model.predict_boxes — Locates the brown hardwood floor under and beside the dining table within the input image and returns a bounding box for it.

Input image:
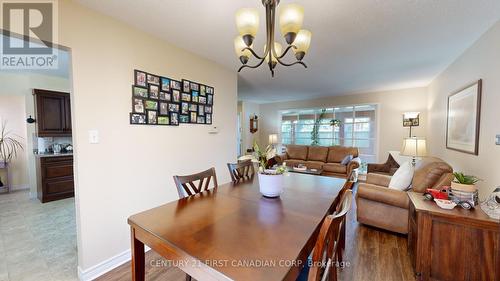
[97,185,415,281]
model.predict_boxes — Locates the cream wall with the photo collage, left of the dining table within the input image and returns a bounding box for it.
[59,0,237,274]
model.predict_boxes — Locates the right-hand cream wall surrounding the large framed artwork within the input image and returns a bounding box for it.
[427,22,500,198]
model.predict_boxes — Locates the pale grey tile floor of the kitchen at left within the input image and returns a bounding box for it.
[0,191,78,281]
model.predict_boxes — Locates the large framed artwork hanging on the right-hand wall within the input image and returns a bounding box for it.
[446,80,482,155]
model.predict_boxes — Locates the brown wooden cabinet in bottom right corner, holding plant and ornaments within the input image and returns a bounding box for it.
[408,192,500,281]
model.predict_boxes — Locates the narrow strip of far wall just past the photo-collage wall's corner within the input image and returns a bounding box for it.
[241,101,260,154]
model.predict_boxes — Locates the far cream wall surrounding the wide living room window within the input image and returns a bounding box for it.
[260,88,427,161]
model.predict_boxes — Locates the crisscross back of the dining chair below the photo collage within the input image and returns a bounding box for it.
[174,168,217,199]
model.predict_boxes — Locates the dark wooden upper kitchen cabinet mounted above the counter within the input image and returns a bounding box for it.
[34,89,72,137]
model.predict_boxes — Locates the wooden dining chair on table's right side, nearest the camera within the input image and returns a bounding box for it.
[297,190,352,281]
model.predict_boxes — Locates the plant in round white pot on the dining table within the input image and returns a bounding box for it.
[253,142,287,198]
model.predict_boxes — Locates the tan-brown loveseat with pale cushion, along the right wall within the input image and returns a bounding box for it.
[356,157,453,234]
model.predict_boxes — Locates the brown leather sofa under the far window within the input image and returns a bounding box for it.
[279,145,361,177]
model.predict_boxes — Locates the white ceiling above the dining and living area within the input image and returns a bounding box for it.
[78,0,500,103]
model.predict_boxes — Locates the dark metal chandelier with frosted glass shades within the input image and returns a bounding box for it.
[234,0,311,77]
